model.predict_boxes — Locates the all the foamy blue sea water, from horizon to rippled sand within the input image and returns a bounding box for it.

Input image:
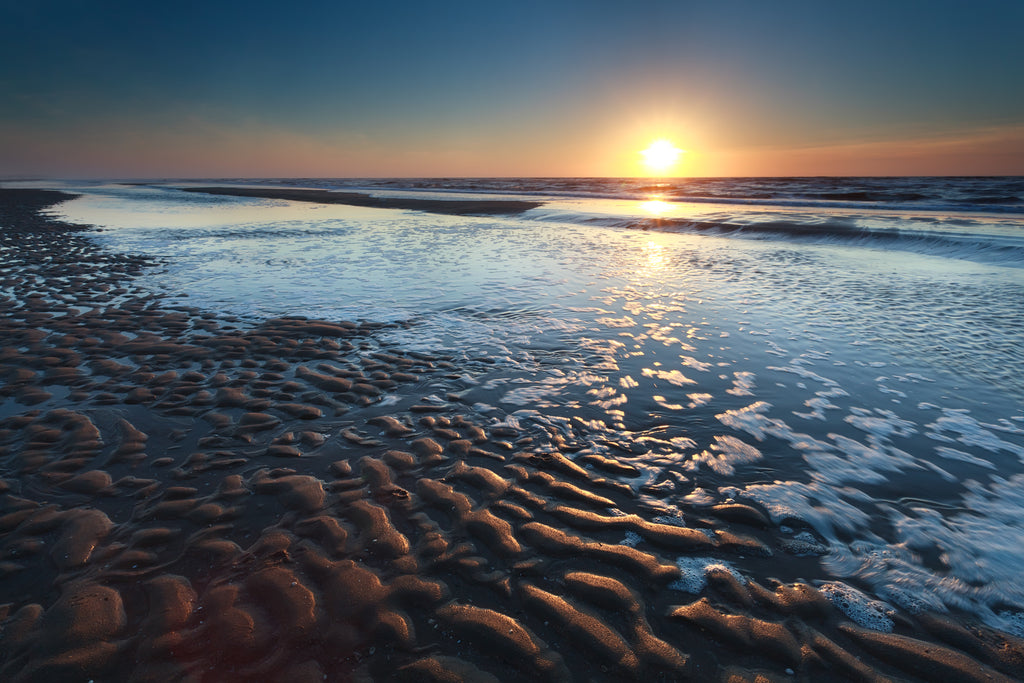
[46,178,1024,635]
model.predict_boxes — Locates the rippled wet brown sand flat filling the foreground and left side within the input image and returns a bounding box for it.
[0,188,1024,682]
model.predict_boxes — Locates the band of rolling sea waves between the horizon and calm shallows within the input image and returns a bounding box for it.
[151,177,1024,267]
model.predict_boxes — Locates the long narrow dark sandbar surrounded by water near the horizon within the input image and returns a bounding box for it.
[182,187,542,216]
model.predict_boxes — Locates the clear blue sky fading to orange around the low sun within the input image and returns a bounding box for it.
[0,0,1024,178]
